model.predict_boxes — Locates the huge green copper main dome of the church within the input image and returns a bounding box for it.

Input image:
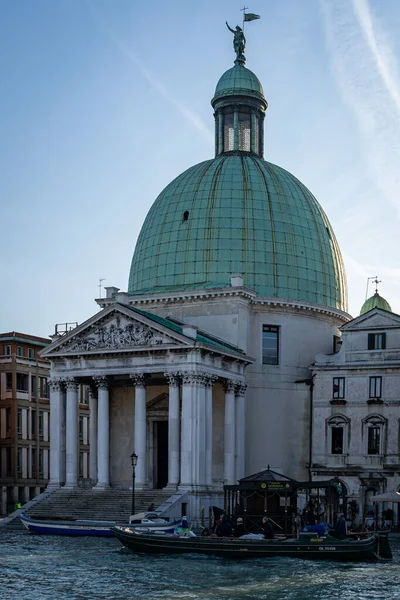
[128,152,347,310]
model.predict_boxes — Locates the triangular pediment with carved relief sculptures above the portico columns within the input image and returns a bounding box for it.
[42,304,192,357]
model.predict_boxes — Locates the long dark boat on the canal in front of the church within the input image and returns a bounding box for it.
[112,526,392,561]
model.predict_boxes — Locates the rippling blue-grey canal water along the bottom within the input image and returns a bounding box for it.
[0,532,400,600]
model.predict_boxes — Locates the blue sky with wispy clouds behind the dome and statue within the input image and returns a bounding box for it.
[0,0,400,336]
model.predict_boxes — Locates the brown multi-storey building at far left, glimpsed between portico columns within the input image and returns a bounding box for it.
[0,331,89,514]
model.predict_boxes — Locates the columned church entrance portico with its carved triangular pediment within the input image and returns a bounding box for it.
[42,302,252,491]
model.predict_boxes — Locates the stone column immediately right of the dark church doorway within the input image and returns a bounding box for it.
[165,373,180,488]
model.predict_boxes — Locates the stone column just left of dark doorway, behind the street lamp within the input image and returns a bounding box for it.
[131,373,147,489]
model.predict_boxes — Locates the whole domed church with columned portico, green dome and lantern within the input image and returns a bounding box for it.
[43,30,350,510]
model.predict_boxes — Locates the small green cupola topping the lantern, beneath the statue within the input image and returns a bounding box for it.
[212,63,265,103]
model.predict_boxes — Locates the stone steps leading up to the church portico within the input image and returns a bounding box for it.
[22,488,171,523]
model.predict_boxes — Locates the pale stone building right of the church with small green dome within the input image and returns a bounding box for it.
[312,293,400,522]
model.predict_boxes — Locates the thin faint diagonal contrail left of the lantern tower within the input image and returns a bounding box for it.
[86,0,214,142]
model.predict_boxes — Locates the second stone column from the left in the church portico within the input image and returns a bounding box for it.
[65,378,78,489]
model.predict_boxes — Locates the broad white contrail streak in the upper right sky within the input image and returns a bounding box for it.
[320,0,400,216]
